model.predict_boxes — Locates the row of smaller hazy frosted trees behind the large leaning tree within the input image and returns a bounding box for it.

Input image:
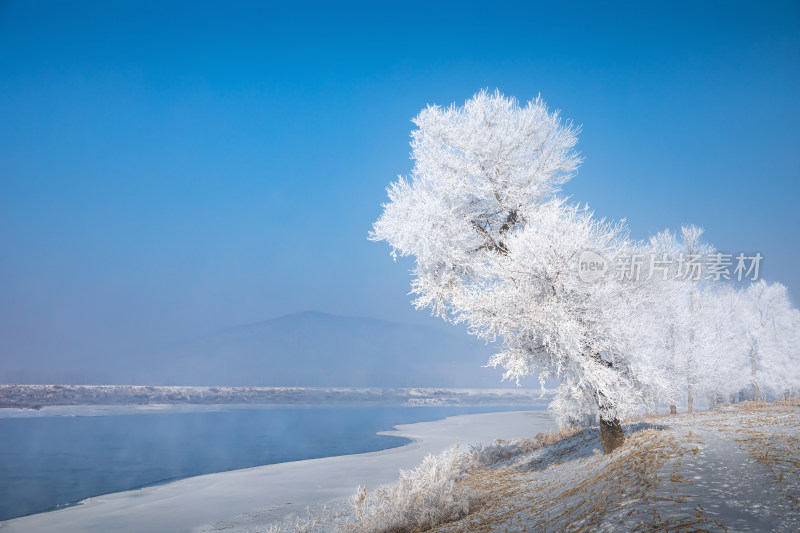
[636,226,800,413]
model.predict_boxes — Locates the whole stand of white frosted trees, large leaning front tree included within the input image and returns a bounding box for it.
[371,92,800,451]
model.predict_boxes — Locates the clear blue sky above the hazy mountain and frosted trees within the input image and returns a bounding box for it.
[0,0,800,362]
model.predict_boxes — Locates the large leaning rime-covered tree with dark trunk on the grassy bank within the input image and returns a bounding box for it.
[371,92,657,451]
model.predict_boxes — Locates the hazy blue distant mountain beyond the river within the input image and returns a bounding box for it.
[84,311,509,388]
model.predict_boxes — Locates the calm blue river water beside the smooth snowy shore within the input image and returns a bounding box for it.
[0,406,544,520]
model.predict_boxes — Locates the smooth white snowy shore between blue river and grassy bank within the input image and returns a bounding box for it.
[0,411,555,533]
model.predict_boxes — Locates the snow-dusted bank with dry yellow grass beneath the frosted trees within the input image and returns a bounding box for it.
[422,402,800,532]
